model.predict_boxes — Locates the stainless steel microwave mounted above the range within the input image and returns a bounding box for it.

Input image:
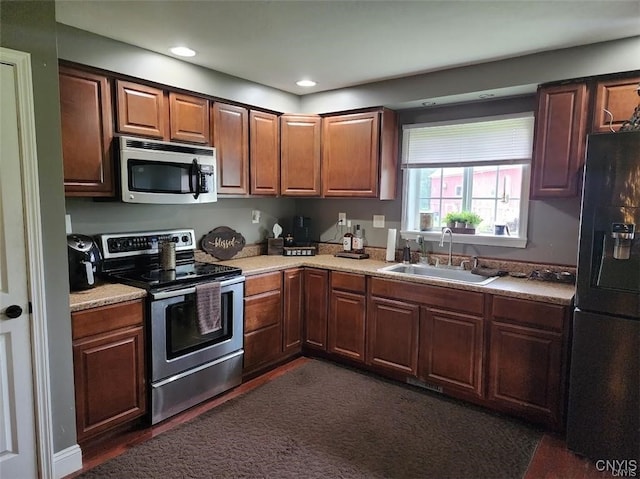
[119,136,218,204]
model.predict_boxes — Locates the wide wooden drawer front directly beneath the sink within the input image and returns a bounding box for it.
[370,278,484,316]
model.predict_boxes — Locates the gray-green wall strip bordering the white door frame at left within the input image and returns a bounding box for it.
[0,1,76,452]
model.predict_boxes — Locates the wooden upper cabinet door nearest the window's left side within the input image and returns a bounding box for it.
[322,111,380,198]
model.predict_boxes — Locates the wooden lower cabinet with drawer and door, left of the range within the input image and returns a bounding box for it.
[71,301,147,444]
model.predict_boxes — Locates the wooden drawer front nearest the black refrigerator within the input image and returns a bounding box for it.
[492,296,566,332]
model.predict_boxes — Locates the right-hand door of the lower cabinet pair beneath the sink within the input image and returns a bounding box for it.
[418,308,483,396]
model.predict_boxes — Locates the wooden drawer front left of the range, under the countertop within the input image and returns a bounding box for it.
[71,301,144,340]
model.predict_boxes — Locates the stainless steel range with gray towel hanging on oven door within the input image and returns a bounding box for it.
[97,229,245,424]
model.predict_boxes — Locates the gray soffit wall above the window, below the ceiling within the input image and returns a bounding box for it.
[301,36,640,113]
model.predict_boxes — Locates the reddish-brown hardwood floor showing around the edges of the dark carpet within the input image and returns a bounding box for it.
[64,357,613,479]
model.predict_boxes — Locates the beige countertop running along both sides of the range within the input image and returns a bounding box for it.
[70,251,575,312]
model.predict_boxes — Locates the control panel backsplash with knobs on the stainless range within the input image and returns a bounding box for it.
[98,229,195,259]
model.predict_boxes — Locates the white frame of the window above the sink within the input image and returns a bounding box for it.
[400,111,533,248]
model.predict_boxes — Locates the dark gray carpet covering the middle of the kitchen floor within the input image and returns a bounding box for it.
[80,360,542,479]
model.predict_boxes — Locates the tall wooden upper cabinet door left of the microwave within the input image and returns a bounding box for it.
[59,66,115,196]
